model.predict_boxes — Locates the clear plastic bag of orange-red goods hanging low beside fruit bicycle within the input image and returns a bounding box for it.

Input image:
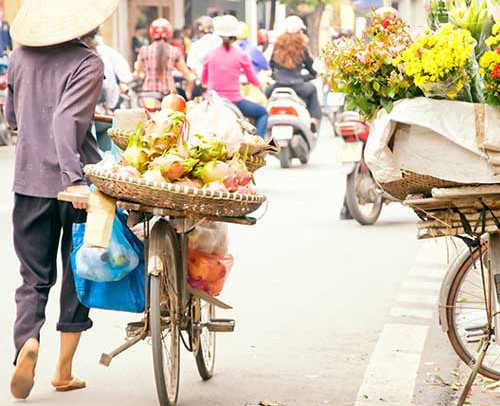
[188,249,234,296]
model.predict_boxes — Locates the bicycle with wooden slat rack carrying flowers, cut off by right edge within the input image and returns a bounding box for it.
[405,185,500,406]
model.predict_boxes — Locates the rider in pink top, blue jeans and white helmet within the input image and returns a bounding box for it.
[201,15,268,137]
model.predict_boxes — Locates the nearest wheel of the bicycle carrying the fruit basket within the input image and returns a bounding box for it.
[148,220,180,406]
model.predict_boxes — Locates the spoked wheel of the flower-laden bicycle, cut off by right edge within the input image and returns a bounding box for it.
[446,243,500,381]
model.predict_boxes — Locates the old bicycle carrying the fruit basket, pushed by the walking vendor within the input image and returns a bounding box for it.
[58,193,256,406]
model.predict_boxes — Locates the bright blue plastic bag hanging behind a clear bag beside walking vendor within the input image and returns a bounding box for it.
[71,210,146,313]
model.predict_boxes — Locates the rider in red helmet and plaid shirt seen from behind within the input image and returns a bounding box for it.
[135,18,193,95]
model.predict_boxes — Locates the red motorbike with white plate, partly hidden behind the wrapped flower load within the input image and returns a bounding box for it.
[335,111,386,225]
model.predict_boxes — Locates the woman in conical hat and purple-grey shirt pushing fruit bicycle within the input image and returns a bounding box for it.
[6,0,119,399]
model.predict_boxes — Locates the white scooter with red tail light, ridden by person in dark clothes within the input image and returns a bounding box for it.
[267,87,319,168]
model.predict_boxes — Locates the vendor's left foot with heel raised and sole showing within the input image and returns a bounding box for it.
[10,338,40,399]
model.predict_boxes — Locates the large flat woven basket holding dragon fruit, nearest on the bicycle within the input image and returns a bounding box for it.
[84,165,266,217]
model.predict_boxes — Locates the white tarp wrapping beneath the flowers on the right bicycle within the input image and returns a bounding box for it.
[365,97,500,183]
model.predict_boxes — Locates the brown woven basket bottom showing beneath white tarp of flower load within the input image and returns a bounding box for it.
[380,170,462,200]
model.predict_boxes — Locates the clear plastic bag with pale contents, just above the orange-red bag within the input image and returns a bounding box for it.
[189,221,228,256]
